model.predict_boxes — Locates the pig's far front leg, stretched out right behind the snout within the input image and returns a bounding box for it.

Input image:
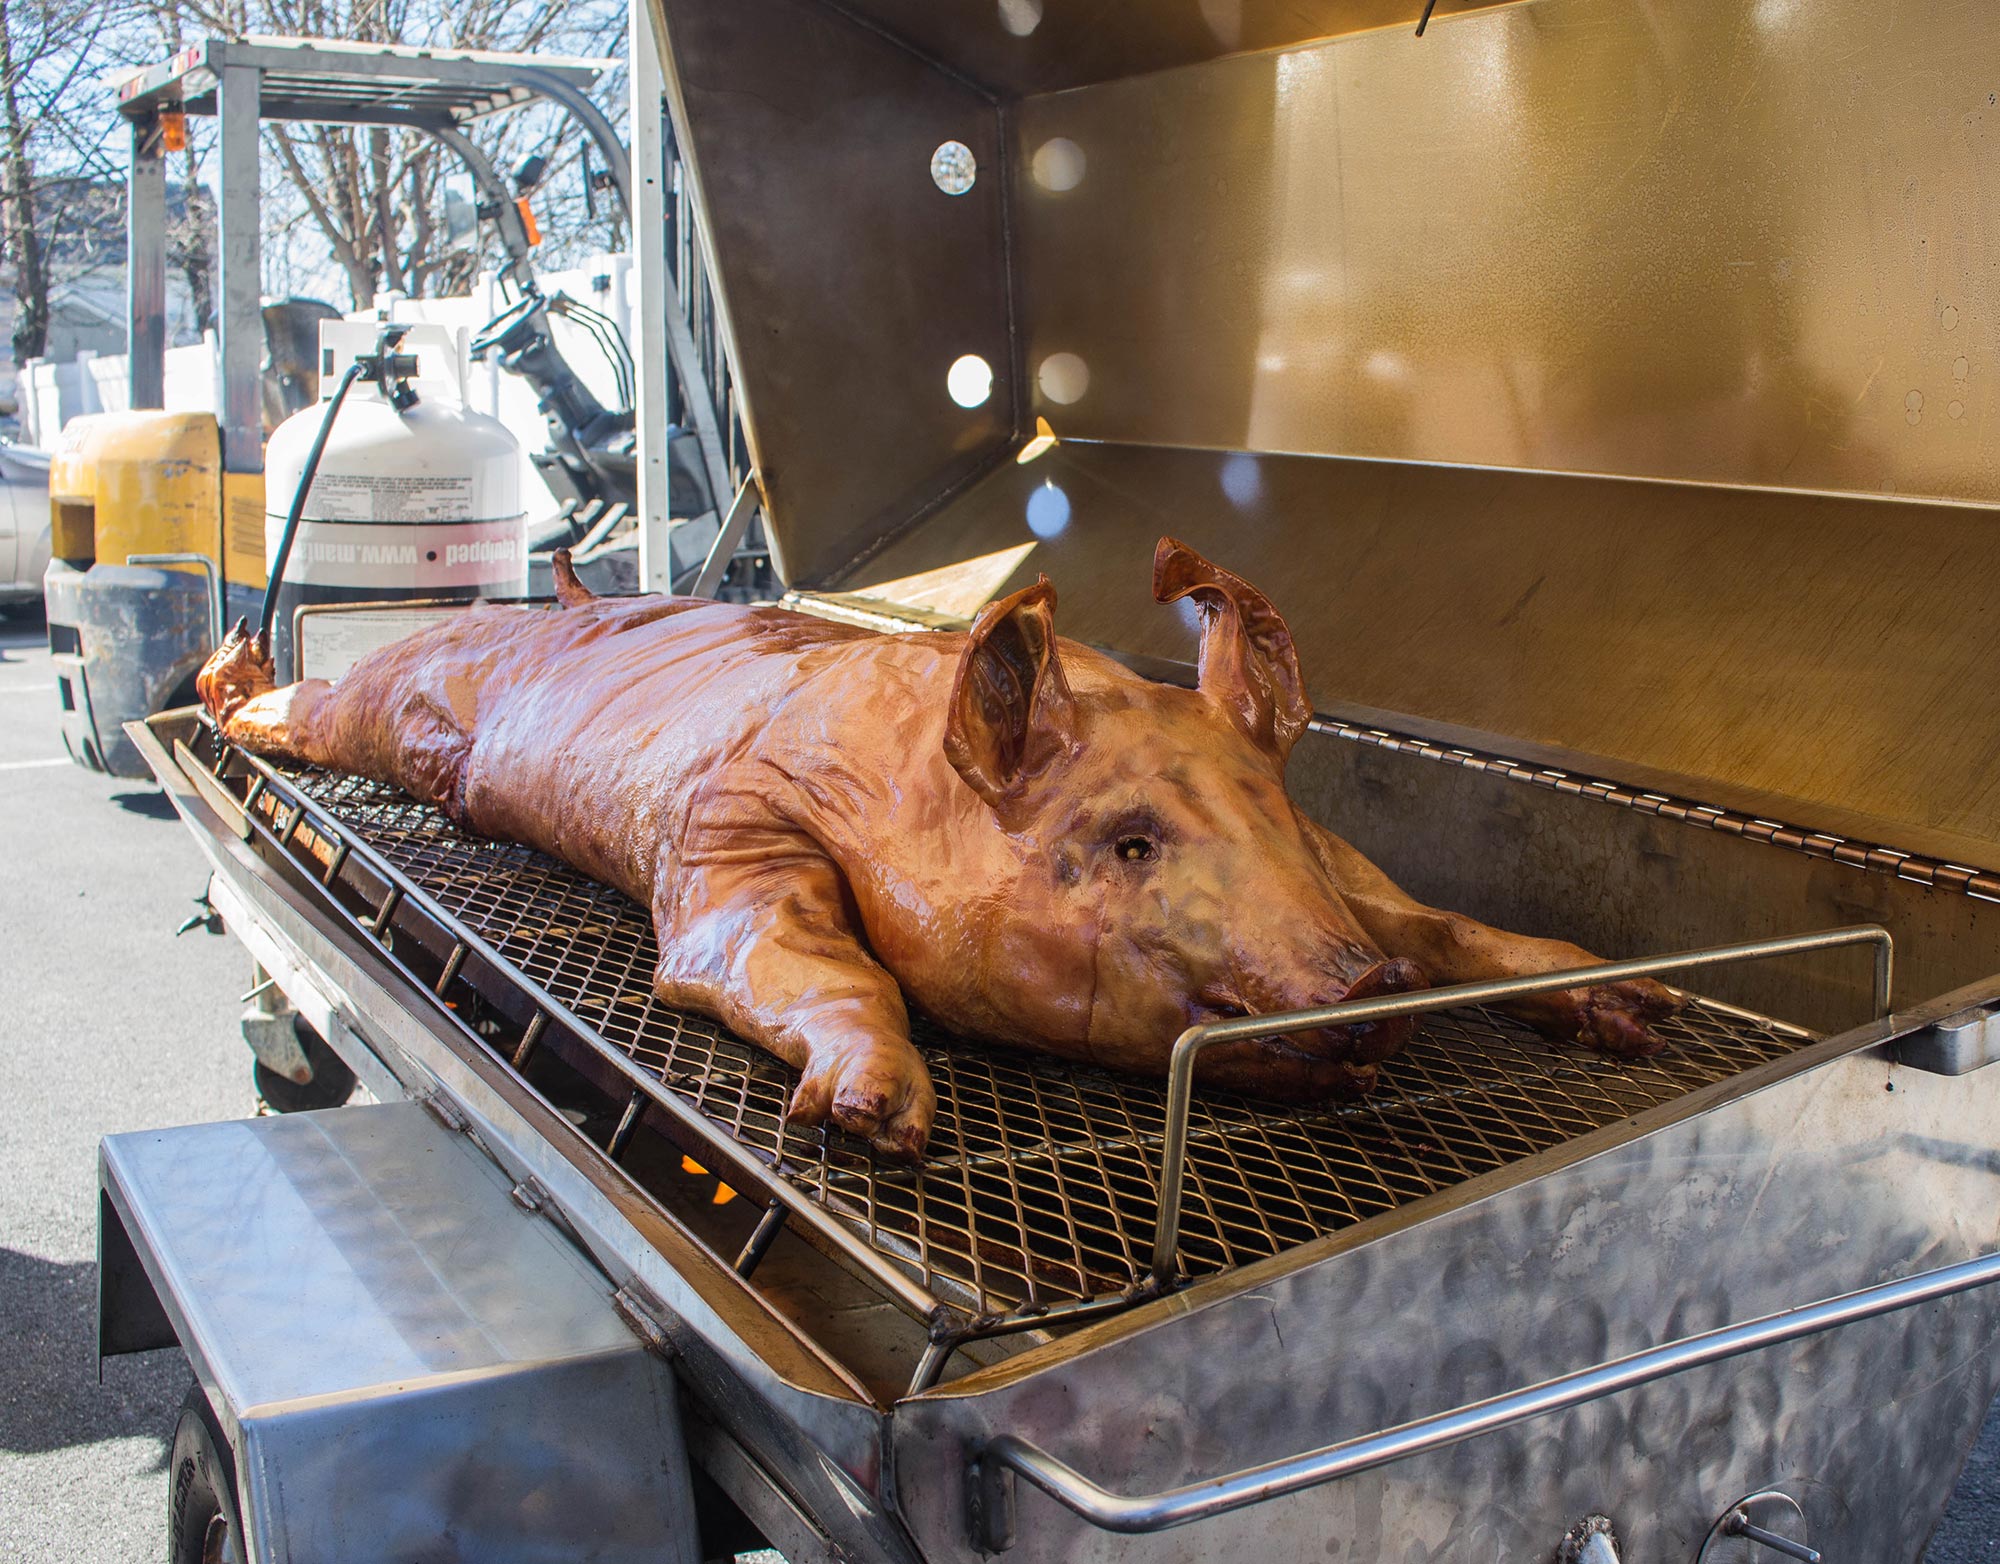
[1300,814,1680,1056]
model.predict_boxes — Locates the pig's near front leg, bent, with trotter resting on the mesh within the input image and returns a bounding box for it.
[654,834,938,1162]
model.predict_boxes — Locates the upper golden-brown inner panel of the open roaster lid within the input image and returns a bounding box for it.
[1016,0,2000,500]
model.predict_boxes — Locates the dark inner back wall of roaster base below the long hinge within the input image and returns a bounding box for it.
[1290,720,2000,1032]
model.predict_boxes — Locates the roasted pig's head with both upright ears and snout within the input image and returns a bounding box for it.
[928,538,1424,1096]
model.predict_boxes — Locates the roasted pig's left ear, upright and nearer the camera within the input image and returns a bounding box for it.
[944,576,1070,808]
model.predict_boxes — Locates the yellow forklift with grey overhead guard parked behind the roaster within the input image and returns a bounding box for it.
[44,38,680,776]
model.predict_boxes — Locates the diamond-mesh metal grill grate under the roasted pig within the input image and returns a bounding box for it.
[278,772,1806,1320]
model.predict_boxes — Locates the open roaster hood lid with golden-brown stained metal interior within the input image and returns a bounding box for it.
[654,0,2000,868]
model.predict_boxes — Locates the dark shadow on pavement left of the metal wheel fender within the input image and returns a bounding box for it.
[0,1248,188,1472]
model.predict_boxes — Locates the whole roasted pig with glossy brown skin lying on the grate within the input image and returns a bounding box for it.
[200,538,1676,1158]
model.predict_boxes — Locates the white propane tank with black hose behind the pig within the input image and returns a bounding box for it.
[264,320,528,680]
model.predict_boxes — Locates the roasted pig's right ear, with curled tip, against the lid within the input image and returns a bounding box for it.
[1152,538,1312,760]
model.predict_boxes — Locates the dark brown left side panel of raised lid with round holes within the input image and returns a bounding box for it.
[654,0,1022,580]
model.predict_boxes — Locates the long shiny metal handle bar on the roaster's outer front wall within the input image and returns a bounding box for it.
[968,1254,2000,1552]
